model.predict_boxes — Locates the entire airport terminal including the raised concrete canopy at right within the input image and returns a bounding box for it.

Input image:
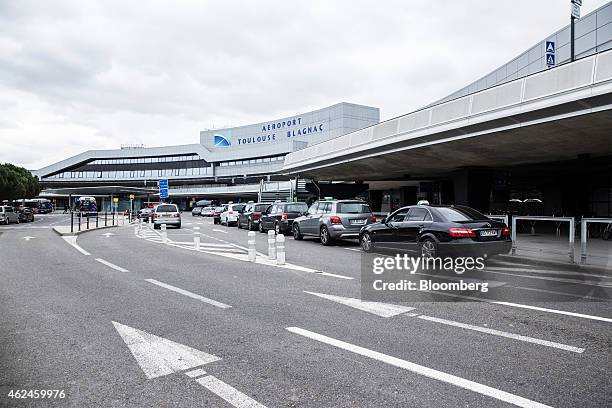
[35,3,612,217]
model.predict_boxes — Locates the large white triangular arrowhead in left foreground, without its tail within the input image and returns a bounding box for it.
[113,322,221,379]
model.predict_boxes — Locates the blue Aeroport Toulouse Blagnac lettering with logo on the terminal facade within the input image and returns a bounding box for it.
[213,117,325,147]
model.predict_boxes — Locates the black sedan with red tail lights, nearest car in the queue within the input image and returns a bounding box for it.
[359,205,512,257]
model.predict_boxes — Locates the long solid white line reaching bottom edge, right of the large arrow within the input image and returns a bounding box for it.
[286,327,551,408]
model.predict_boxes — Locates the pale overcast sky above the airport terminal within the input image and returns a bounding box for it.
[0,0,607,169]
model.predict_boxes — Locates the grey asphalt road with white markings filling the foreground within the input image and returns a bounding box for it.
[0,214,612,407]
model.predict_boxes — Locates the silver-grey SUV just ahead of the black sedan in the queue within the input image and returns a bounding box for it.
[293,200,376,245]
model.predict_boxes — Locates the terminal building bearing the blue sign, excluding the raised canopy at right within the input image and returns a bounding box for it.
[34,102,380,208]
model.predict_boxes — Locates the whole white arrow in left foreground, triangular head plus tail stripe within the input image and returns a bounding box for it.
[113,322,266,408]
